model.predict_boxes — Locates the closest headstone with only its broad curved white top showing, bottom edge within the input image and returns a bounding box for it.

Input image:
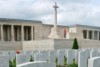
[17,61,56,67]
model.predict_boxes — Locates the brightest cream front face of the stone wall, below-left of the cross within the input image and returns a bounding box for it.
[22,39,54,50]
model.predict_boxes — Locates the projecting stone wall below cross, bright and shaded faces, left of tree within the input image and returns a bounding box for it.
[23,39,73,50]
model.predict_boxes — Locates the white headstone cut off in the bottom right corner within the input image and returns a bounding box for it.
[88,57,100,67]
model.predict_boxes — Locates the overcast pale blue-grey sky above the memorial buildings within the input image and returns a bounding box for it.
[0,0,100,26]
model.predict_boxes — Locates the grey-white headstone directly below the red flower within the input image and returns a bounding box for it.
[16,54,30,65]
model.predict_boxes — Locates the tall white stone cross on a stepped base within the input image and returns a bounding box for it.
[48,3,59,39]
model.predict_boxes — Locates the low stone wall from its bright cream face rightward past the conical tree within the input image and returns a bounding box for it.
[22,39,100,50]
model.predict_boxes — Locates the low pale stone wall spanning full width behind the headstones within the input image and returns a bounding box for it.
[0,39,100,50]
